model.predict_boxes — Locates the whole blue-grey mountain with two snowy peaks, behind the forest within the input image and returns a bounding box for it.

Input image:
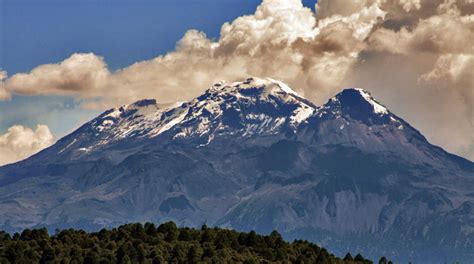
[0,78,474,263]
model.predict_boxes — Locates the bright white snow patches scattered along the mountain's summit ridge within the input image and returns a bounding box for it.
[17,77,444,161]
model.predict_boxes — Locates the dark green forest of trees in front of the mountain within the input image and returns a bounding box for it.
[0,222,390,264]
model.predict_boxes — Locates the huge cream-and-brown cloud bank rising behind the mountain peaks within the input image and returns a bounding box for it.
[0,0,474,159]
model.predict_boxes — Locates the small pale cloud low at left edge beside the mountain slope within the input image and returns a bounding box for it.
[0,125,54,165]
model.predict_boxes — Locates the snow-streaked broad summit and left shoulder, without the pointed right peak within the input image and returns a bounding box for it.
[60,78,317,154]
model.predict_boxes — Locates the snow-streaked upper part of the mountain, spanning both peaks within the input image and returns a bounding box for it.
[56,77,404,155]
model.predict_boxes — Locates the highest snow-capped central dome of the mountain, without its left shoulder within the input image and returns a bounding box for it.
[163,77,316,144]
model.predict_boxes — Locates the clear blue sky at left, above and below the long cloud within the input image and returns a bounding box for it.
[0,0,314,137]
